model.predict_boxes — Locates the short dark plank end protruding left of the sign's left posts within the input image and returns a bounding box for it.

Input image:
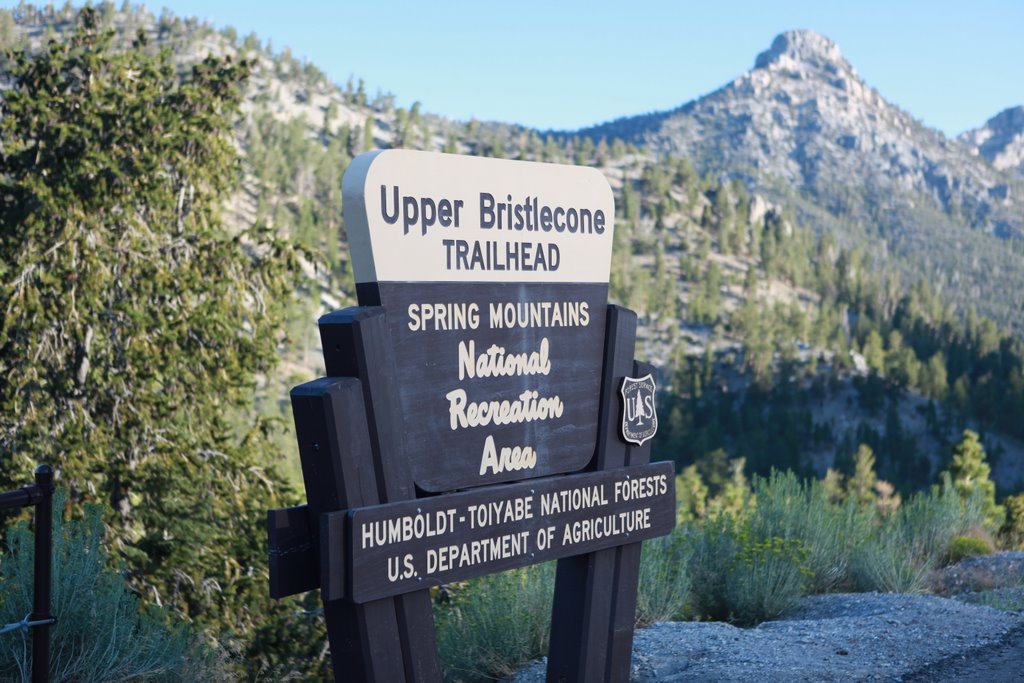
[266,505,319,599]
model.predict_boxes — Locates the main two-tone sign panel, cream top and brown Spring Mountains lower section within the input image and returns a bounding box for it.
[344,150,614,493]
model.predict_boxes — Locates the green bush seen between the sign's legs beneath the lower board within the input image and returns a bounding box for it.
[435,562,555,681]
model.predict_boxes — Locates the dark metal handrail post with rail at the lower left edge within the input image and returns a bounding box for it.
[0,465,57,683]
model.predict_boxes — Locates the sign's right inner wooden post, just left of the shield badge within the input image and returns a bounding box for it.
[547,305,637,683]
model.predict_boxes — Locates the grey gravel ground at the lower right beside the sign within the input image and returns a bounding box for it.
[508,593,1024,683]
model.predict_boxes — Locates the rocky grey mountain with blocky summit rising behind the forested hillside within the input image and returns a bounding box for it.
[580,31,1024,329]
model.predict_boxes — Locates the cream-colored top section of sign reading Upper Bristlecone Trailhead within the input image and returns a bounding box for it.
[342,150,615,283]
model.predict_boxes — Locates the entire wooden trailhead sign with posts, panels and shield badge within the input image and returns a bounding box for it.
[268,151,675,682]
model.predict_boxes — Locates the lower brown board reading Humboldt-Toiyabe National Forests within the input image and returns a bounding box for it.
[345,463,676,603]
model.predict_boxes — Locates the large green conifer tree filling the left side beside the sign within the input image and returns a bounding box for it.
[0,8,298,643]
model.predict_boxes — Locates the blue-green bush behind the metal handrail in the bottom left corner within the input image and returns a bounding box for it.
[0,495,231,683]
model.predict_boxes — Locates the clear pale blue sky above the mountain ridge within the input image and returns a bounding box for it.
[9,0,1024,135]
